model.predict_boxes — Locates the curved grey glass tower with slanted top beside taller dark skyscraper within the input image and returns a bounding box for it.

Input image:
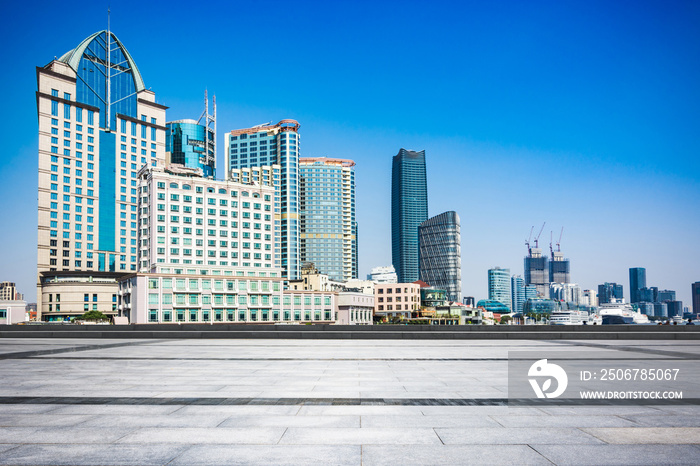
[418,211,462,302]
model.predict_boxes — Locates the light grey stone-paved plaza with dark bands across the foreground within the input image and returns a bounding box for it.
[0,338,700,465]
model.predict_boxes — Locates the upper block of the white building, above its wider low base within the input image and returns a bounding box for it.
[139,165,281,276]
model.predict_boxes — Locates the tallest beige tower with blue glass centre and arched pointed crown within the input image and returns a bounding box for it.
[37,31,167,320]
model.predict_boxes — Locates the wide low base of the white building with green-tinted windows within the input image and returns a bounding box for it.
[119,270,338,324]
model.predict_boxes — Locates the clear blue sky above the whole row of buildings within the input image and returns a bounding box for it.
[0,1,700,305]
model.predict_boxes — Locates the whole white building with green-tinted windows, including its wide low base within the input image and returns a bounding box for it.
[117,165,337,323]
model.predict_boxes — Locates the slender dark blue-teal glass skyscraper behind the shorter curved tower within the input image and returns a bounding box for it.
[391,149,428,283]
